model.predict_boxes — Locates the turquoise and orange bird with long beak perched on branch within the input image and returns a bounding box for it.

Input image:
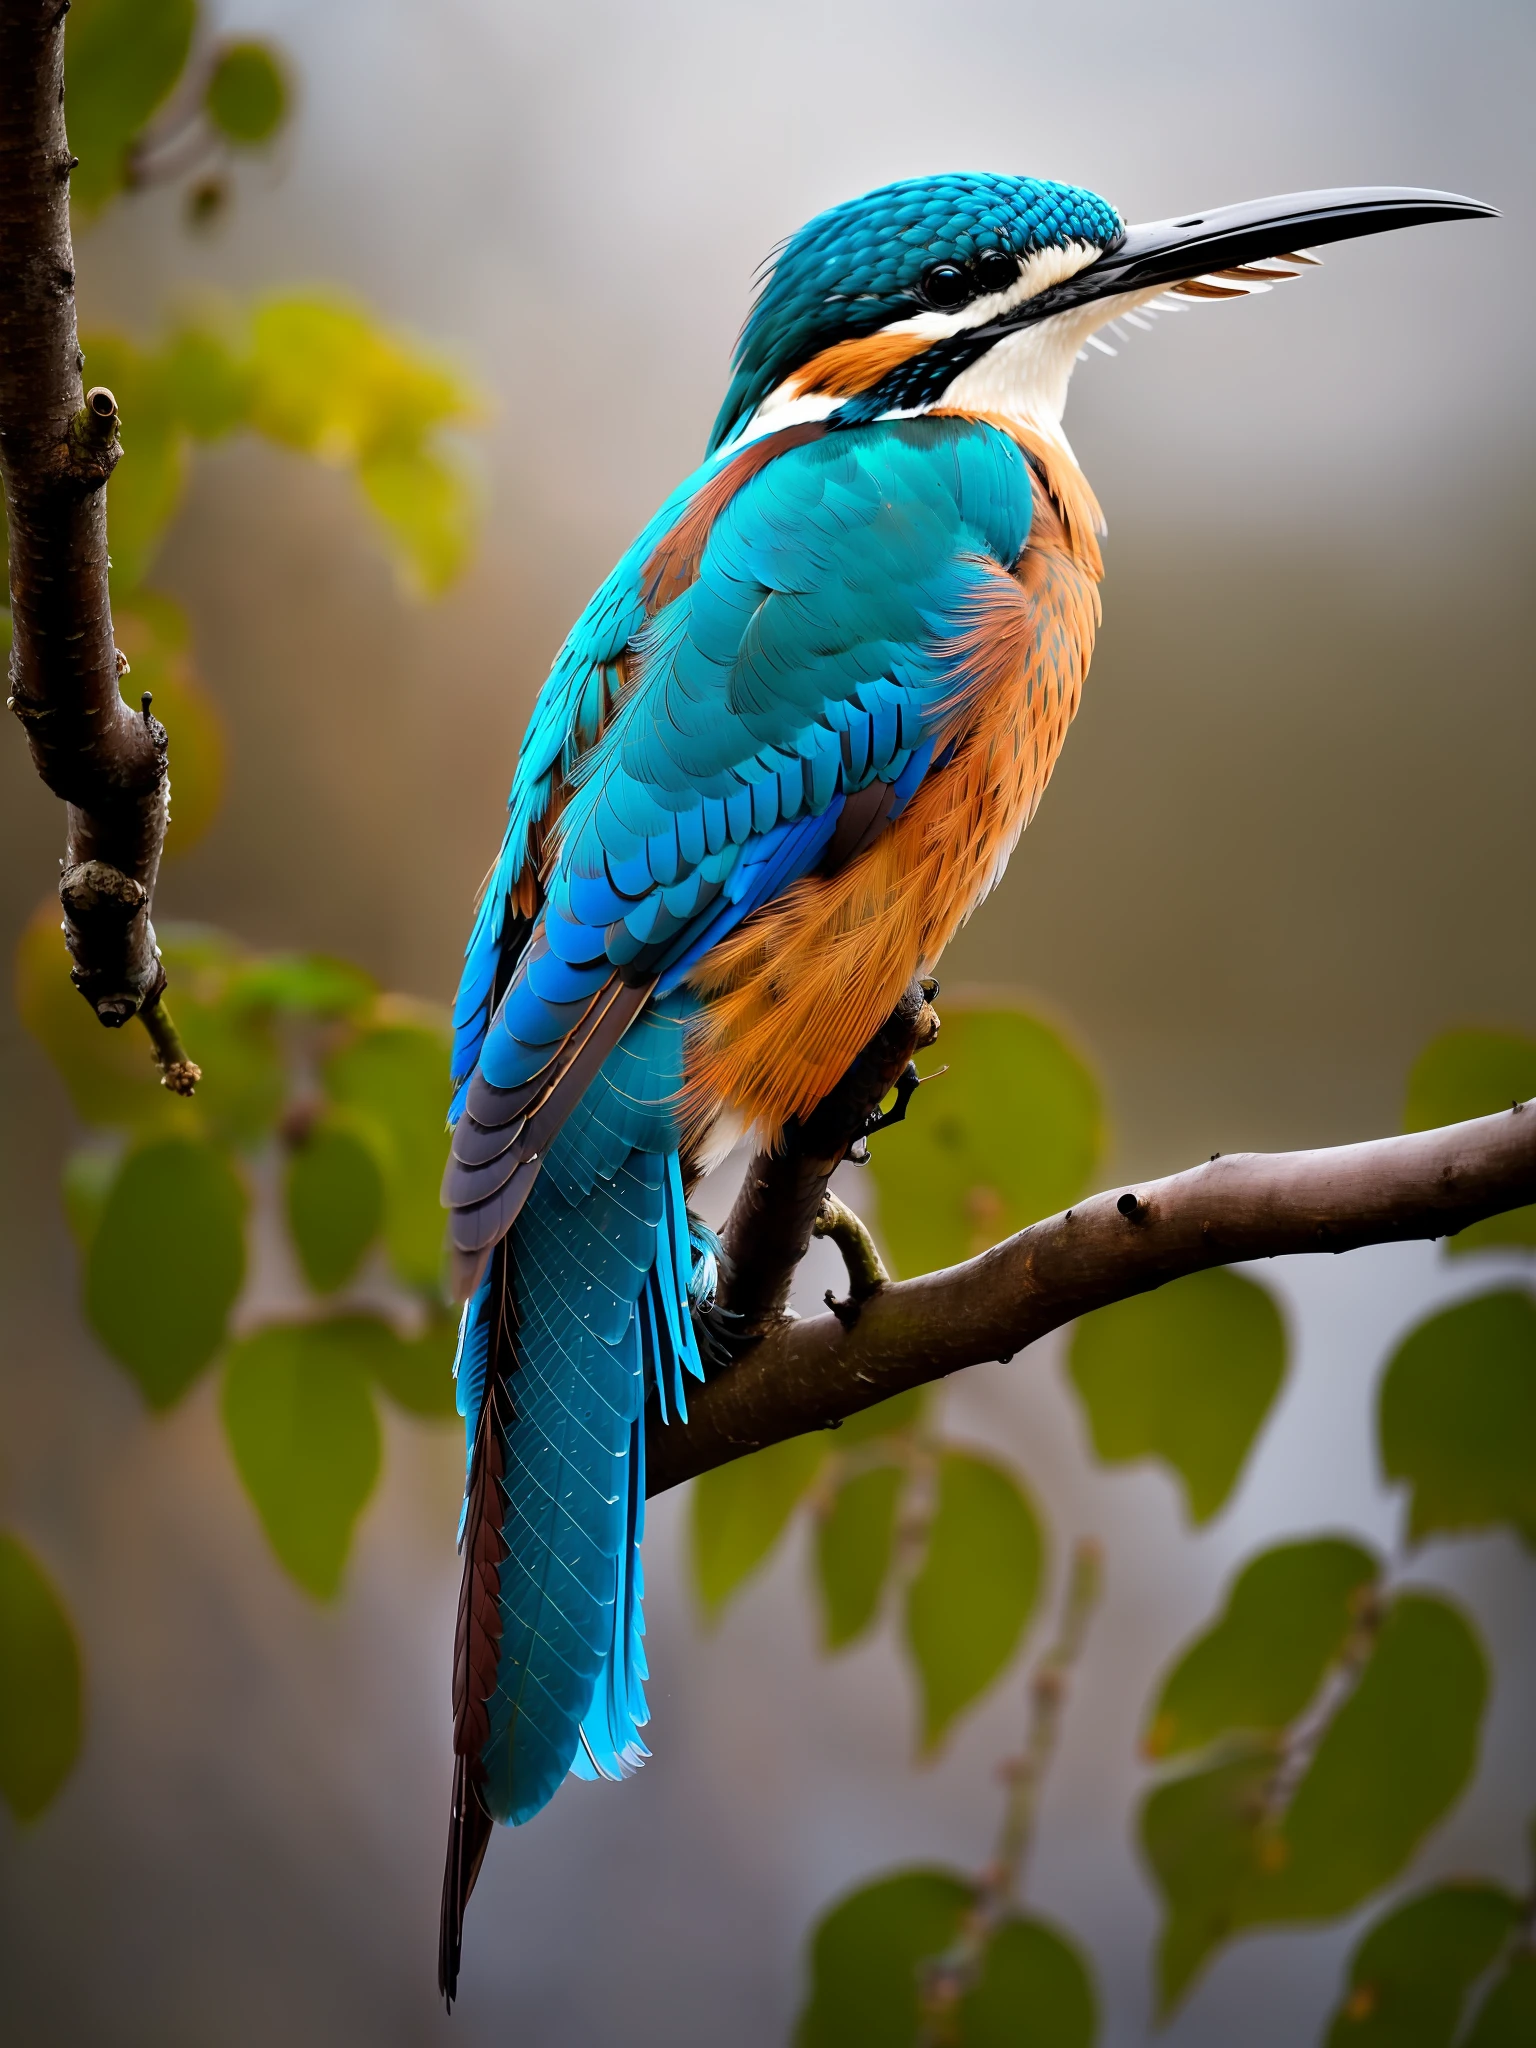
[438,172,1495,2005]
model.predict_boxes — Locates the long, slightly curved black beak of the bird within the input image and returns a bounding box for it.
[1018,184,1497,324]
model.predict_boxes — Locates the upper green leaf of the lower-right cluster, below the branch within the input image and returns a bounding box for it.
[1143,1536,1380,1757]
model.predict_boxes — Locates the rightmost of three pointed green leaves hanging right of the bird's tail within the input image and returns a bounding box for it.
[907,1450,1044,1751]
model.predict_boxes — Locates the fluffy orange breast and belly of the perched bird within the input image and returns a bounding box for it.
[686,420,1102,1143]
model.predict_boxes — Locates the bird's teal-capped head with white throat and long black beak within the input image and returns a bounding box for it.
[711,172,1495,449]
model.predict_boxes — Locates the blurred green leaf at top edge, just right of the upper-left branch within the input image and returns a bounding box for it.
[63,0,197,215]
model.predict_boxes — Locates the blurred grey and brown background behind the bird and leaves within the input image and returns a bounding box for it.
[0,0,1536,2048]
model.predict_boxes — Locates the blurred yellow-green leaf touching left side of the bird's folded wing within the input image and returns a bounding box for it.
[326,1020,449,1288]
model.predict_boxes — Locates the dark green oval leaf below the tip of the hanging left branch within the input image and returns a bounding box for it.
[86,1139,246,1409]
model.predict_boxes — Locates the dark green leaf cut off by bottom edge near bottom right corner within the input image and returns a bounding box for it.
[1327,1882,1520,2048]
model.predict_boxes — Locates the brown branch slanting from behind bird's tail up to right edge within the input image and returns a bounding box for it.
[645,1100,1536,1493]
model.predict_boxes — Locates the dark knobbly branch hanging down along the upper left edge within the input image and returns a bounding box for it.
[0,0,190,1092]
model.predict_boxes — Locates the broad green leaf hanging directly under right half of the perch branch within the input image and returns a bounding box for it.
[1067,1268,1286,1524]
